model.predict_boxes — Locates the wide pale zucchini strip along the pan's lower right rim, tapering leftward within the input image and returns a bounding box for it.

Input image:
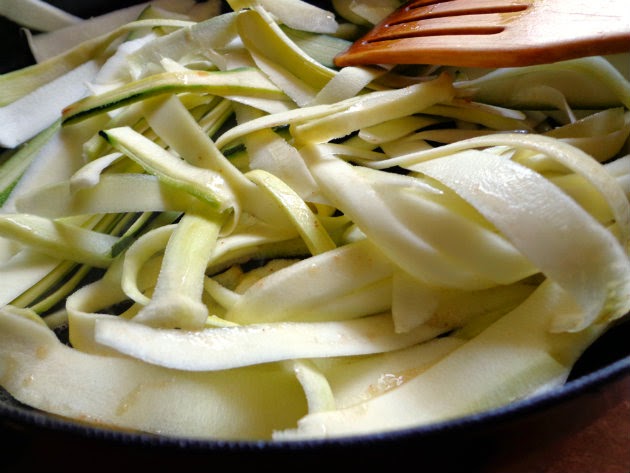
[278,282,605,439]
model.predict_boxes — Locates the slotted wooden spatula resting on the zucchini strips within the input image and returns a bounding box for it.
[335,0,630,67]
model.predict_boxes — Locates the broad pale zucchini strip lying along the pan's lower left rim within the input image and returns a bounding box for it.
[0,307,306,439]
